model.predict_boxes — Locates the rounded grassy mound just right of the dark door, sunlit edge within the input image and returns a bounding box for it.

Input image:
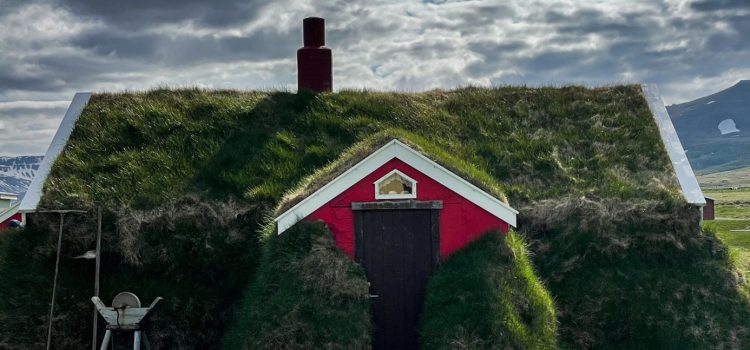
[420,232,557,349]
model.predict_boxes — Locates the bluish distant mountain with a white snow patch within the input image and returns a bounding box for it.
[667,80,750,174]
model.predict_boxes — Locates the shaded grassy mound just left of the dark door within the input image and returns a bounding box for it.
[223,221,372,349]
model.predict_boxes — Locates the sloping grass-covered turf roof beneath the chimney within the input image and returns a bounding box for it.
[41,85,679,208]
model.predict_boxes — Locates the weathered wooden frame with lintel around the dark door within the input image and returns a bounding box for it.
[352,200,443,270]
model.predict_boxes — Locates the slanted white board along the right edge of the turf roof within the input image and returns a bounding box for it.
[641,84,706,206]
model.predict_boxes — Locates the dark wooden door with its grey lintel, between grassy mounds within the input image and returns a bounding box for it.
[352,201,442,350]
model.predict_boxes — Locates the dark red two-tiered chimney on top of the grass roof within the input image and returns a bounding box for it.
[297,17,333,92]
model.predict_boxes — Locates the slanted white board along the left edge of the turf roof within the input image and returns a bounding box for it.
[19,92,91,213]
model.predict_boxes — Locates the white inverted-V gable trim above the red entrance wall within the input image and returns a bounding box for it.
[274,139,518,234]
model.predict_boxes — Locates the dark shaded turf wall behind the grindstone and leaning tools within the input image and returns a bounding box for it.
[0,197,260,349]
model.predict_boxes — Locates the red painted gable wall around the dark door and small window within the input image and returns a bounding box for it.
[306,158,508,258]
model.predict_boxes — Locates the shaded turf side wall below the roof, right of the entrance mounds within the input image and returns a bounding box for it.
[520,198,750,349]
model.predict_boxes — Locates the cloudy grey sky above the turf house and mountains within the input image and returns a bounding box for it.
[0,0,750,155]
